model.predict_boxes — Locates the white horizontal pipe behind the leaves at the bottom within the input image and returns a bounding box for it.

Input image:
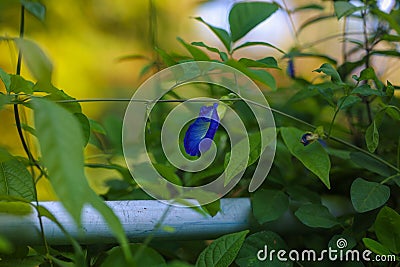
[0,198,251,245]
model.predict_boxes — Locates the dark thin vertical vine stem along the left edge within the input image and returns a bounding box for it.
[14,5,53,266]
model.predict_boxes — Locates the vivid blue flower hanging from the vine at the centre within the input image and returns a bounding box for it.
[183,103,219,156]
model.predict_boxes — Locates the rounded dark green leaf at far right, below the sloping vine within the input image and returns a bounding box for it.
[350,178,390,212]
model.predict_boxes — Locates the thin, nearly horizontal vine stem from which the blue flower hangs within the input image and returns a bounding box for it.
[15,98,400,173]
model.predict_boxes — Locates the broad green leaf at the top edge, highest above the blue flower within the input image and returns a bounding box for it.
[229,2,278,42]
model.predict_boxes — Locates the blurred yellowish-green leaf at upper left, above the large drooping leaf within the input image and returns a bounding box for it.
[15,39,53,84]
